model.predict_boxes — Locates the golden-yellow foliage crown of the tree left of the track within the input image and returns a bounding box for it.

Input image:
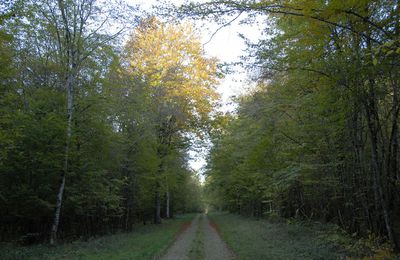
[125,18,218,130]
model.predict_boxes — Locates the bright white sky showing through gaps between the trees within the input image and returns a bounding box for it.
[136,0,261,178]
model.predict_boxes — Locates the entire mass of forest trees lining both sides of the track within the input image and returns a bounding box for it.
[0,0,400,253]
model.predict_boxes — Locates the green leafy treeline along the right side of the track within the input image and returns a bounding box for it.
[200,0,400,248]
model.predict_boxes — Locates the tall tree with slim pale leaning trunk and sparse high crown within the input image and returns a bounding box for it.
[12,0,133,244]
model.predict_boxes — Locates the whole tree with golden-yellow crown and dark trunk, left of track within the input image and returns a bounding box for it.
[125,17,217,223]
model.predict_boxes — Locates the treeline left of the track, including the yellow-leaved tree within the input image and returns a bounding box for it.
[0,0,217,243]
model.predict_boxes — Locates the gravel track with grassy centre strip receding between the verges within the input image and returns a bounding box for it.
[161,214,235,260]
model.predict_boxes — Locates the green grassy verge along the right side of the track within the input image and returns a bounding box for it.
[209,213,390,260]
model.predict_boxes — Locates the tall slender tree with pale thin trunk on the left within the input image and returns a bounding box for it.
[27,0,132,244]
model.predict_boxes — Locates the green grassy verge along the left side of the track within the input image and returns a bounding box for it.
[0,215,194,259]
